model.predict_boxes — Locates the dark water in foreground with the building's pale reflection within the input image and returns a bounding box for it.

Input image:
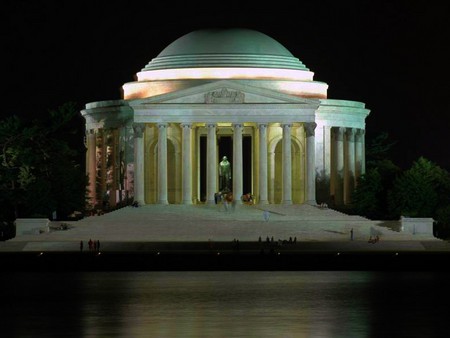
[0,271,449,338]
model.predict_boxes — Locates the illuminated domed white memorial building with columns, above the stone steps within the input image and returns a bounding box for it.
[81,29,369,206]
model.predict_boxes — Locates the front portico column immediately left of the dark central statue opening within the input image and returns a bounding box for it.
[206,123,217,205]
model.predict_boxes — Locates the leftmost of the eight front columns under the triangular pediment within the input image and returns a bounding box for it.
[133,123,145,205]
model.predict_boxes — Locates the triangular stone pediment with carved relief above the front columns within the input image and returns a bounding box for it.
[132,80,317,105]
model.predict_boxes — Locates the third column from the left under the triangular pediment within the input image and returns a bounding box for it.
[181,123,192,204]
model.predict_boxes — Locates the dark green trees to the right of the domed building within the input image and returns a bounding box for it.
[347,133,450,236]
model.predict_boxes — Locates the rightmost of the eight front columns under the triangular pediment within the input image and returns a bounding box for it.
[303,122,317,205]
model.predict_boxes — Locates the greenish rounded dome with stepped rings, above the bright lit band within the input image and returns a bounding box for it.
[142,28,308,71]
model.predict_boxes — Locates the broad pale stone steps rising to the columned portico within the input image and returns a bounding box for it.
[0,205,440,251]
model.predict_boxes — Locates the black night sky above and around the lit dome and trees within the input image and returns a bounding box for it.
[0,0,450,169]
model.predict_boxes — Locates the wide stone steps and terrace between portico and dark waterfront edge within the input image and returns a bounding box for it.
[0,204,449,252]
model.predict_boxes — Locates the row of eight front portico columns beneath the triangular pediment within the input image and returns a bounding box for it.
[133,123,316,204]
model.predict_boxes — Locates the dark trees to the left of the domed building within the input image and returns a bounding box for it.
[0,102,87,239]
